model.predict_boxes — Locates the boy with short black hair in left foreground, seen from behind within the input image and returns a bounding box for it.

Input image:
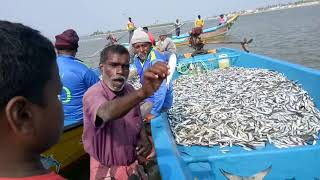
[0,21,64,180]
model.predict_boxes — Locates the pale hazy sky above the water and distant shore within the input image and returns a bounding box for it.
[0,0,294,38]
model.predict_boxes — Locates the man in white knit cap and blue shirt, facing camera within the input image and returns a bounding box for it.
[131,30,173,121]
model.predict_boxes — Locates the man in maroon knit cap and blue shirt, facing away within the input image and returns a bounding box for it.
[55,29,99,125]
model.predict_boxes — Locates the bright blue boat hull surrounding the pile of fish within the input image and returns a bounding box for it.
[151,48,320,180]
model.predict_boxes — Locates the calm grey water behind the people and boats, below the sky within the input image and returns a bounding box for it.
[78,5,320,70]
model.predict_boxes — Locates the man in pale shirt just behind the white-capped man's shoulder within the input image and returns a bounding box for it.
[157,31,177,54]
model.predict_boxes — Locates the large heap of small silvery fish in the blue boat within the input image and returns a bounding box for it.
[168,68,320,150]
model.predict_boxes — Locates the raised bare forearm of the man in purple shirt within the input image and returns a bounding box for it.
[97,90,146,122]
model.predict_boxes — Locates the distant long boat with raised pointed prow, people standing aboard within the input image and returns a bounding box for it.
[172,14,239,46]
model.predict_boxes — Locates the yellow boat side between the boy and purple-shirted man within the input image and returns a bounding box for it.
[43,121,85,172]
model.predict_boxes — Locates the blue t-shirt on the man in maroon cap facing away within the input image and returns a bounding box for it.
[57,55,99,126]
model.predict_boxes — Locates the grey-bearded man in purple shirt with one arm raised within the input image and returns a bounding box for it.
[83,44,168,180]
